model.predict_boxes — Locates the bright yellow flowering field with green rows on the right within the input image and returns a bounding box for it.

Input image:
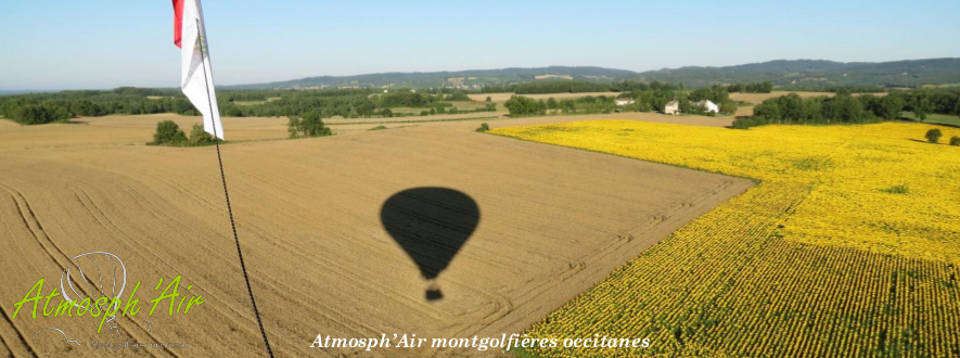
[493,120,960,357]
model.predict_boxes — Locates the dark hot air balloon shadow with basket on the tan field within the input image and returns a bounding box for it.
[380,187,480,301]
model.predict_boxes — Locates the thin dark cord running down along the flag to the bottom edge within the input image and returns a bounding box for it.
[196,17,273,358]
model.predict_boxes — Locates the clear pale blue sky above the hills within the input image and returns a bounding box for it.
[0,0,960,90]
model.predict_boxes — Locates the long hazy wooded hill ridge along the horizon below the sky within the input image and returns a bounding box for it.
[229,58,960,89]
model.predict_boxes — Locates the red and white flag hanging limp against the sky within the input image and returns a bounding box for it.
[173,0,223,139]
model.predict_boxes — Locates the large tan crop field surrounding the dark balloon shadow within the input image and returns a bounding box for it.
[0,113,752,357]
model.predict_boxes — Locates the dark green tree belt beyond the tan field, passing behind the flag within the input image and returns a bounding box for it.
[0,87,495,125]
